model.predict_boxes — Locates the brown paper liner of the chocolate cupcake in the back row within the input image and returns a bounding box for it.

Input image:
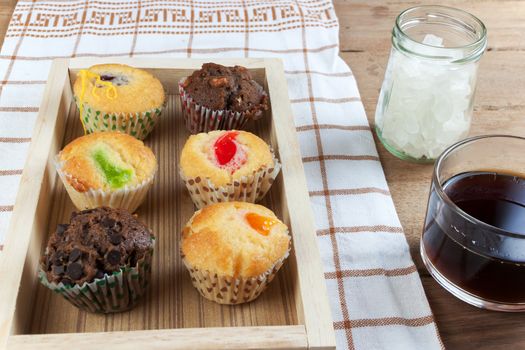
[179,77,266,134]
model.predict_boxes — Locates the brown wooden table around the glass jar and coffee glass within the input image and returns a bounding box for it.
[0,0,525,350]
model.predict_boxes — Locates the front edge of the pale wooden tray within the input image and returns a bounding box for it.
[7,325,308,350]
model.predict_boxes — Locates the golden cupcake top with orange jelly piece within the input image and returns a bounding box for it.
[181,202,290,278]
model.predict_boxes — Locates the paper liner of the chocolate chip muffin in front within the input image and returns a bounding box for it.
[38,240,155,313]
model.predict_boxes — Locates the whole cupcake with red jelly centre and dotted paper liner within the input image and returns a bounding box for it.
[179,130,281,208]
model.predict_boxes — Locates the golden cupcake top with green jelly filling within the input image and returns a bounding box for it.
[57,132,157,192]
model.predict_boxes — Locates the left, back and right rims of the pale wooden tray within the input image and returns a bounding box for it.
[0,57,335,349]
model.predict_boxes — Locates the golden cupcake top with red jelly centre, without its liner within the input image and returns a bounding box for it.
[180,130,275,186]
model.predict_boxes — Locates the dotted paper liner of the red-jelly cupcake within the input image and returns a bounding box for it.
[179,156,281,209]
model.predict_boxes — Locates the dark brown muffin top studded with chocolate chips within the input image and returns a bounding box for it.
[41,207,153,285]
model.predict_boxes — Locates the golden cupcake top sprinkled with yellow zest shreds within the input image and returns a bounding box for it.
[73,64,165,114]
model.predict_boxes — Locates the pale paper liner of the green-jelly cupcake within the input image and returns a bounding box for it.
[55,160,155,213]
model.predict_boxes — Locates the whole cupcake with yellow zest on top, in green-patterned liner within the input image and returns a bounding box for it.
[73,64,165,140]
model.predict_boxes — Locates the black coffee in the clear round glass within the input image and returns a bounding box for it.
[422,172,525,303]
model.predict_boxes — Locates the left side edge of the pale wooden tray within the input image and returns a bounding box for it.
[0,59,73,348]
